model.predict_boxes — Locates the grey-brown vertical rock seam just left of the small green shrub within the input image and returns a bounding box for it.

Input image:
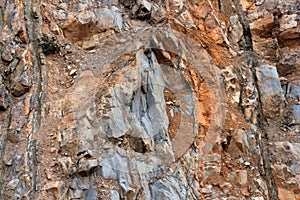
[24,0,47,198]
